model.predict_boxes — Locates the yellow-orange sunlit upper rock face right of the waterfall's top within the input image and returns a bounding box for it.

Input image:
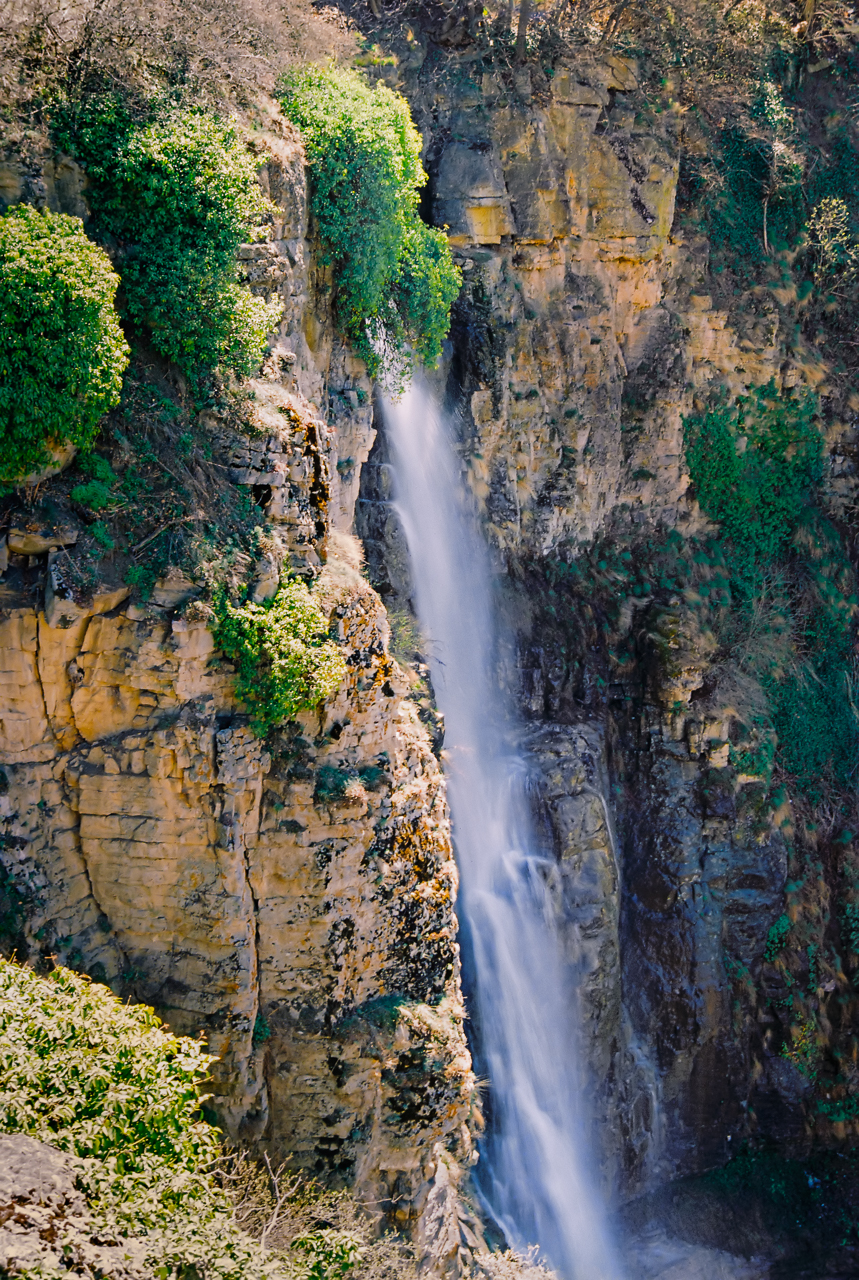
[358,52,790,581]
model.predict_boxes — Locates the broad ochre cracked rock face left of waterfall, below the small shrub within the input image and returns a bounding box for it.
[0,568,474,1239]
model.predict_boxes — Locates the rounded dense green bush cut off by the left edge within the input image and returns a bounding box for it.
[0,205,128,481]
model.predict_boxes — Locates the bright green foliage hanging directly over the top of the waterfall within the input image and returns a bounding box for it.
[280,67,461,379]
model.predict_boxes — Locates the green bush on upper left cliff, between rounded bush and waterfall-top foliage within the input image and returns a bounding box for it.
[58,97,282,375]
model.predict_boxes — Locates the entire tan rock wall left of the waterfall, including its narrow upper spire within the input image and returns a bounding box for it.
[0,104,478,1267]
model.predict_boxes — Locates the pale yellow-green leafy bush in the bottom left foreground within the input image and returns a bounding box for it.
[0,960,361,1280]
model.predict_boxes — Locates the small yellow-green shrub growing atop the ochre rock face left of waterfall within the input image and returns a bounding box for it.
[213,581,346,736]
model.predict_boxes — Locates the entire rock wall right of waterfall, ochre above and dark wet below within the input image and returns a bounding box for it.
[356,47,855,1197]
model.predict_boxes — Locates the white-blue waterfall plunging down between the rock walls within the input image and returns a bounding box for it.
[385,384,621,1280]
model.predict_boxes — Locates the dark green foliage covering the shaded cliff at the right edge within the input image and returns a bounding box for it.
[685,384,859,804]
